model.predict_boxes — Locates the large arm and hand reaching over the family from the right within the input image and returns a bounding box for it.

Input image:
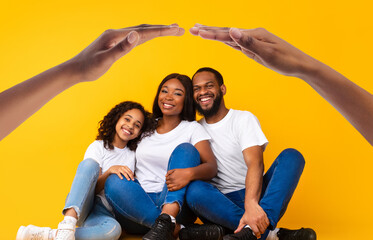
[190,24,373,145]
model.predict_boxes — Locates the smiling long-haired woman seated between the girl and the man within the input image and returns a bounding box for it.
[105,73,217,240]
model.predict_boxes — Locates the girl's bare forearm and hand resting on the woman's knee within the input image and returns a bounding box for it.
[95,165,135,194]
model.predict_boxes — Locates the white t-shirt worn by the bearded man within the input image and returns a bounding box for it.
[200,109,268,194]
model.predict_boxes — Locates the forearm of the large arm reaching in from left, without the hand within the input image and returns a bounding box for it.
[0,61,79,140]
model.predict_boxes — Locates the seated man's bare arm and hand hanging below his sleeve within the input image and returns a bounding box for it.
[235,146,269,238]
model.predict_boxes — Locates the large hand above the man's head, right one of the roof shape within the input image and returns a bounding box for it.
[190,24,315,76]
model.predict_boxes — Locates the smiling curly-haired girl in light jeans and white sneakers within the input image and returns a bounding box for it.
[16,101,154,240]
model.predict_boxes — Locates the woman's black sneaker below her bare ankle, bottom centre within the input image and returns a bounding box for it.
[142,213,175,240]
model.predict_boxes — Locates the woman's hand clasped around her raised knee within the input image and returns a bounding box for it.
[166,168,192,191]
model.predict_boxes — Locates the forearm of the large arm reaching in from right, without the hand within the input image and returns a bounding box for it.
[298,59,373,145]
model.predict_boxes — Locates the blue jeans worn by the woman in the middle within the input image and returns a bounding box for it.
[105,143,200,233]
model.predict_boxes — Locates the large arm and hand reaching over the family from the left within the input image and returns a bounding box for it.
[0,24,184,140]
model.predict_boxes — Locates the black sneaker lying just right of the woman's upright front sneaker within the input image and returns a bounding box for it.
[179,224,224,240]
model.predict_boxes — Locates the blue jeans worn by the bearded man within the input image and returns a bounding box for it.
[186,149,305,239]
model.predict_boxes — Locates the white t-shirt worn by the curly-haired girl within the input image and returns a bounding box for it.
[84,140,135,211]
